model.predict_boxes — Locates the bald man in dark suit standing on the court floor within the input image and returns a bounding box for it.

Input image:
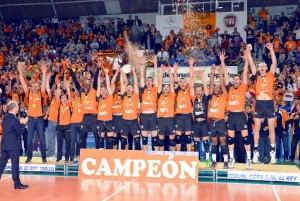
[0,101,28,189]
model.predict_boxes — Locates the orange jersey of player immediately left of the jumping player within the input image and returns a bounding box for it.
[226,83,248,111]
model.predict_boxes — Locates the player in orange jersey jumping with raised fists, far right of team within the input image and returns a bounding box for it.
[247,43,277,164]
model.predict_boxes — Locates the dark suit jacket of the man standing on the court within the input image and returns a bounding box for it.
[1,113,21,151]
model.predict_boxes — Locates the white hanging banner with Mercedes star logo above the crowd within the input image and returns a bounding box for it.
[156,15,183,39]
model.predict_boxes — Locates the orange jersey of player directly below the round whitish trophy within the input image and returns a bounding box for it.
[122,93,139,120]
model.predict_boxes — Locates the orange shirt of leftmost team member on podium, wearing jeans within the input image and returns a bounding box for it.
[25,90,46,117]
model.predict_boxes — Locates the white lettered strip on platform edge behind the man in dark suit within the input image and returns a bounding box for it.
[5,163,55,172]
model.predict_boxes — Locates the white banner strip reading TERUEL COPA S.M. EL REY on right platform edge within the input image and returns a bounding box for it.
[227,171,300,183]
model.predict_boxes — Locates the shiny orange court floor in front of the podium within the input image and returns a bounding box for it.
[0,174,300,201]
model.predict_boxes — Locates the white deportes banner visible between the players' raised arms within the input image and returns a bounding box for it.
[146,66,238,84]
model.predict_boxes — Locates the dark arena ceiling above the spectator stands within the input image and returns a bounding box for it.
[0,0,297,19]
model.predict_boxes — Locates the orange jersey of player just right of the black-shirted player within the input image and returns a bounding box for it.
[208,94,228,119]
